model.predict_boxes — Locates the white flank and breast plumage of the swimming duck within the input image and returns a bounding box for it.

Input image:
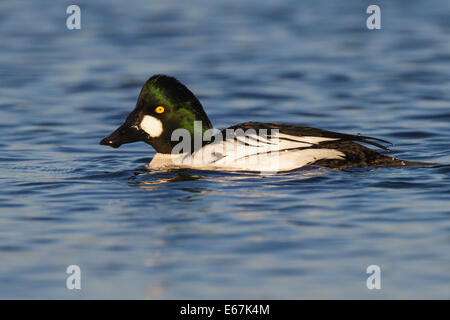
[148,134,345,172]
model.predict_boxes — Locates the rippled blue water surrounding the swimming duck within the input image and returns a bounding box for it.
[0,0,450,299]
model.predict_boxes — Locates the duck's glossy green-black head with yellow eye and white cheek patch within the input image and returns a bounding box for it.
[100,75,212,153]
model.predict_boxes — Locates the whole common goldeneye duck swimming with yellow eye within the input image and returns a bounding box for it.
[100,75,427,172]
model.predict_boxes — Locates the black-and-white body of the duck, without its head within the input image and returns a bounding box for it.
[147,122,421,172]
